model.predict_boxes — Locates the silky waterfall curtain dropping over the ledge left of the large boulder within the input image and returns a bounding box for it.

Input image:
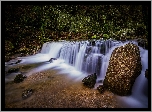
[20,40,121,78]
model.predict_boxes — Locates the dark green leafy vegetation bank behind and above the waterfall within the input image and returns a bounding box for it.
[5,5,150,60]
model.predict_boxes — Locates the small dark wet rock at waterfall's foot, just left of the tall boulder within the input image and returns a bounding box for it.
[82,73,97,88]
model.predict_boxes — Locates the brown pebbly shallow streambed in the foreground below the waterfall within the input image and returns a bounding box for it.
[5,70,121,108]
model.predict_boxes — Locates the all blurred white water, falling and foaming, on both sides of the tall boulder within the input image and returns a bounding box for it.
[6,40,148,108]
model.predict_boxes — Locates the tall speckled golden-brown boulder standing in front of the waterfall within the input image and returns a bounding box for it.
[103,43,142,96]
